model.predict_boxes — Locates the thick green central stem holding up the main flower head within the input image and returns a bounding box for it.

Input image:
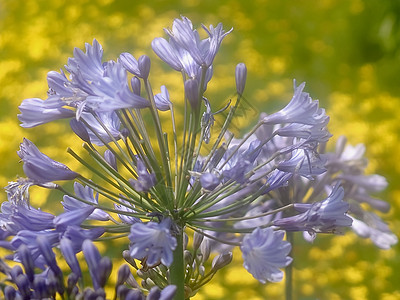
[169,226,185,300]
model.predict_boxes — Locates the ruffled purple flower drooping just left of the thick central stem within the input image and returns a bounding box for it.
[129,219,177,267]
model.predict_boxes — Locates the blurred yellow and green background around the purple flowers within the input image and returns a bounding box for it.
[0,0,400,300]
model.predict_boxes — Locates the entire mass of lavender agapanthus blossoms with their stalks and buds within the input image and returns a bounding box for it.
[0,17,397,299]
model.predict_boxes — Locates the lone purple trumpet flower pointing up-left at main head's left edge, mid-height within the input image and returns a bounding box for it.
[17,138,79,184]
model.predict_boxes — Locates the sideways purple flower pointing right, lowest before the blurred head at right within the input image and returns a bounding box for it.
[273,185,352,237]
